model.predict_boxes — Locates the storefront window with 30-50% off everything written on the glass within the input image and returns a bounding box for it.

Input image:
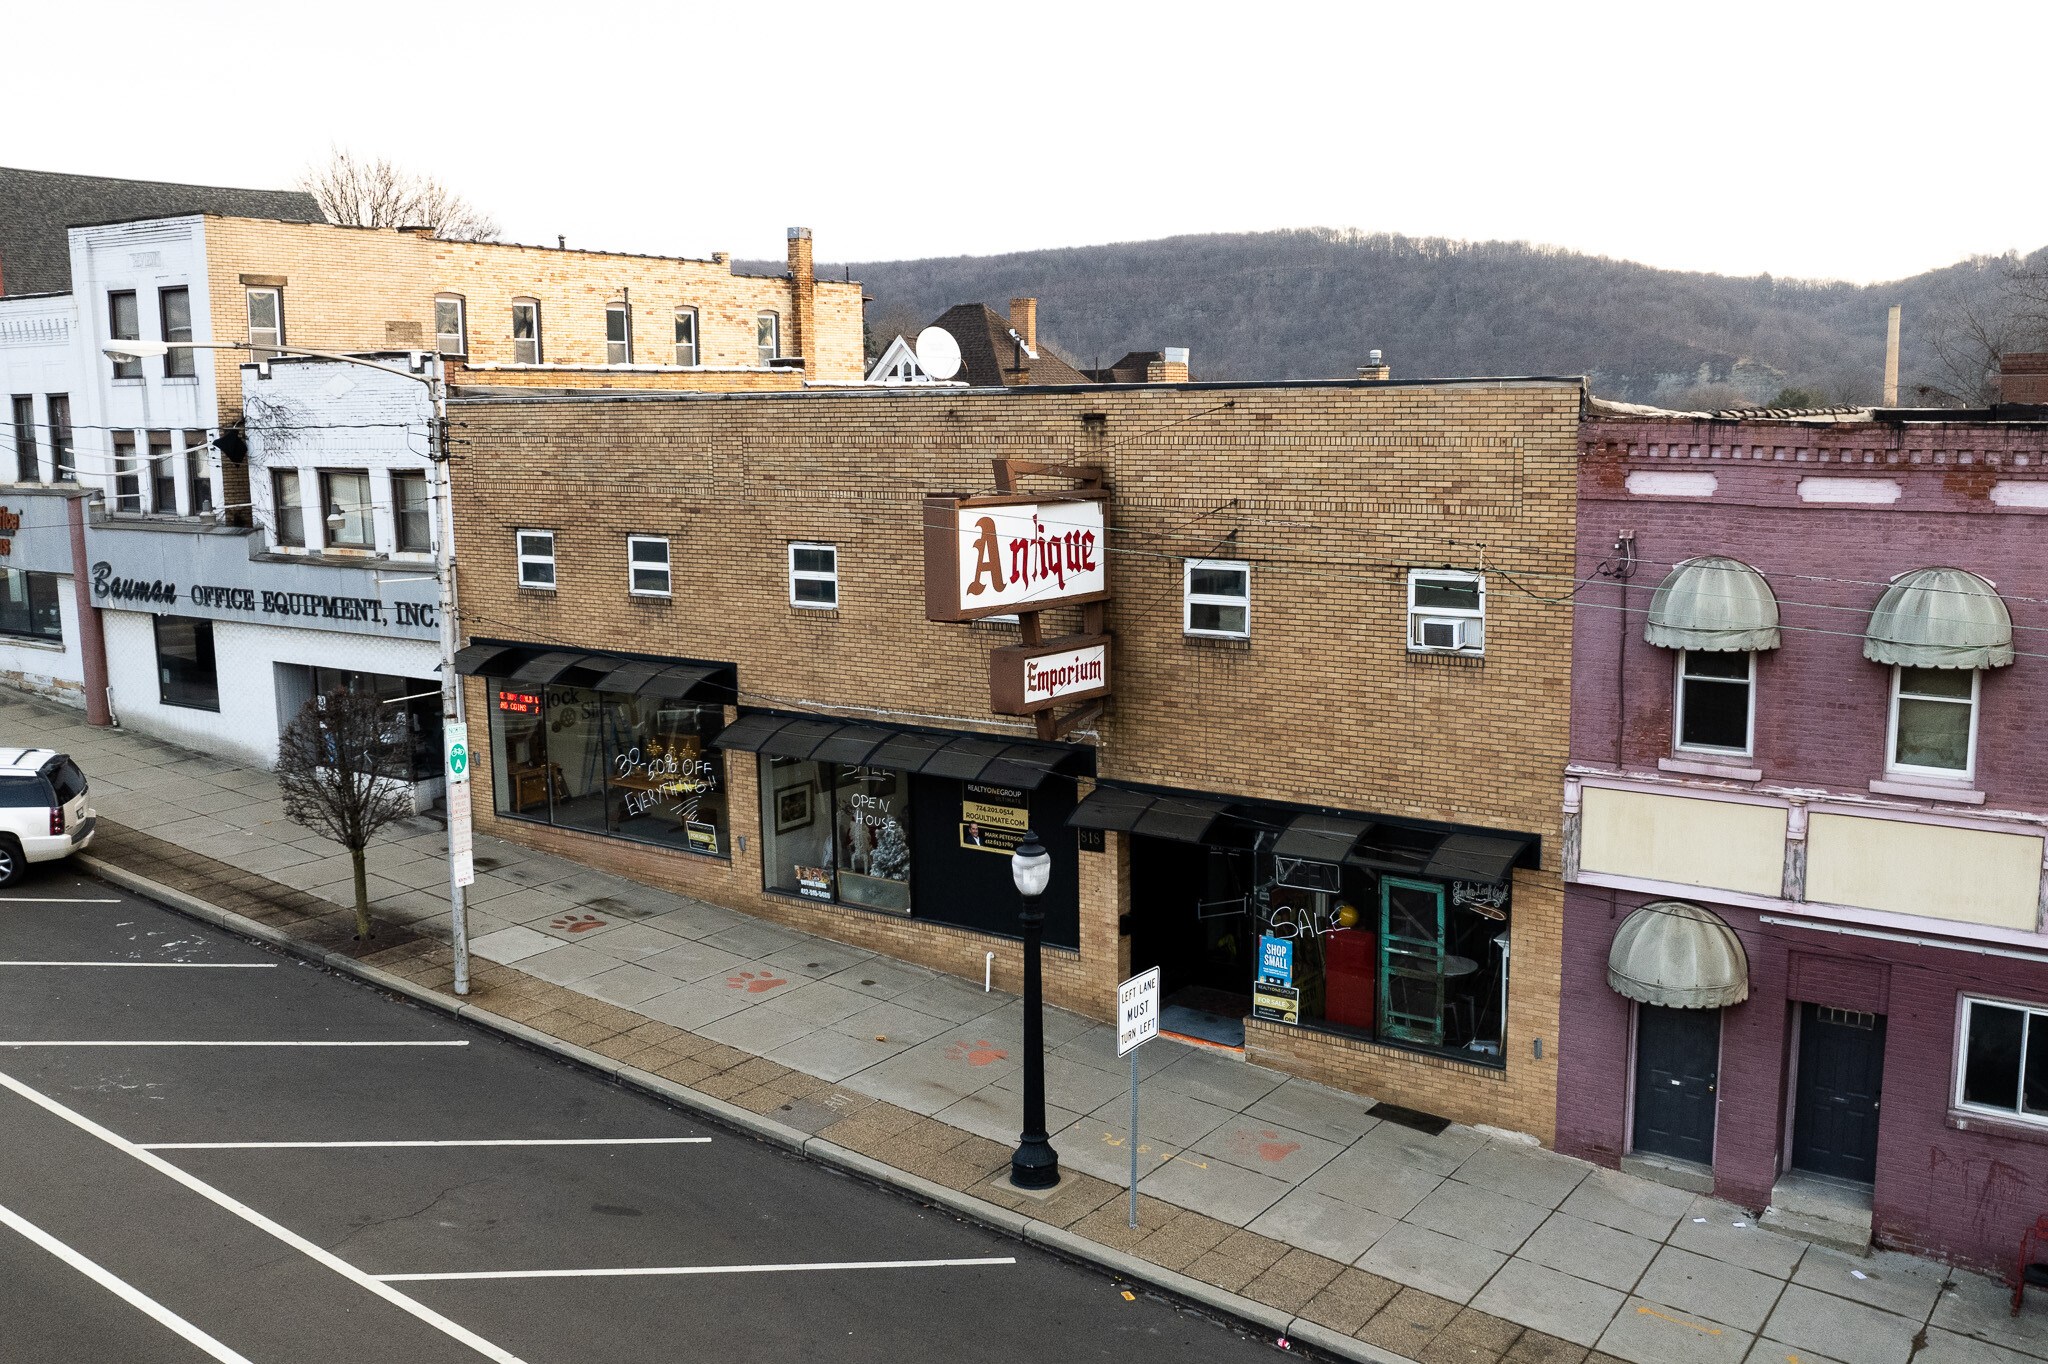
[492,684,731,856]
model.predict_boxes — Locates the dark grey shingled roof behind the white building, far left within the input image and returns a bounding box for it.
[0,166,328,295]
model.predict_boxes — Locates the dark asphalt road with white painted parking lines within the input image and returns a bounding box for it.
[0,864,1274,1364]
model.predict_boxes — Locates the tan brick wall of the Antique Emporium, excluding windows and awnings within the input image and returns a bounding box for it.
[457,383,1579,1139]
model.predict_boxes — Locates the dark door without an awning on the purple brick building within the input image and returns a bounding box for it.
[1792,1004,1884,1184]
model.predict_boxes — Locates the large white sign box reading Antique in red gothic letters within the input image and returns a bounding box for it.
[924,492,1110,621]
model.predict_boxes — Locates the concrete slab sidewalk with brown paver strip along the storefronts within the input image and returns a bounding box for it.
[19,694,2048,1364]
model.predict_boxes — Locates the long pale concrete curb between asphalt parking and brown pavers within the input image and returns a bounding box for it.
[88,854,1413,1364]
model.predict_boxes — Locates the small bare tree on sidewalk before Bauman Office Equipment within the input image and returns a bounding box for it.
[276,690,412,938]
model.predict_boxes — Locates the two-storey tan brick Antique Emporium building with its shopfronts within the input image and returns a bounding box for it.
[453,379,1581,1141]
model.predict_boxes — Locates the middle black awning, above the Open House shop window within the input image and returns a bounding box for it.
[711,713,1096,791]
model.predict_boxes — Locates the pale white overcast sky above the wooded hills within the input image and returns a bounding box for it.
[0,0,2048,281]
